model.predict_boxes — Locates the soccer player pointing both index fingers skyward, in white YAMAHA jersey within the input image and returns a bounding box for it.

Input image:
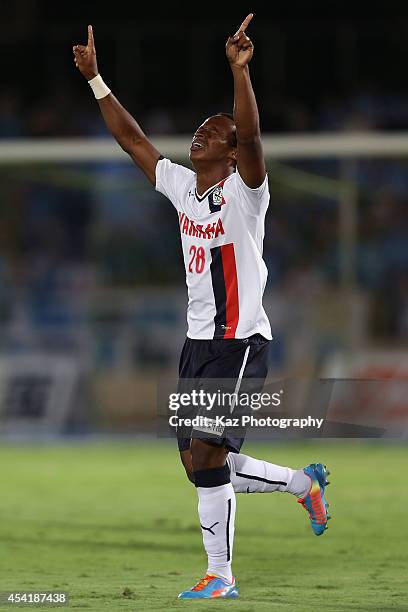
[73,14,329,599]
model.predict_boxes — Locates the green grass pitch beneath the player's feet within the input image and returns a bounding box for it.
[0,441,408,612]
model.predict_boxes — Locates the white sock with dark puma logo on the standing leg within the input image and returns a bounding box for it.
[197,482,236,582]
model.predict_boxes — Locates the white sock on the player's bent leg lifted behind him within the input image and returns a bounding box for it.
[227,453,310,497]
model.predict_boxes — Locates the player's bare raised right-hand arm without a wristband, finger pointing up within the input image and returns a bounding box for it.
[226,13,266,188]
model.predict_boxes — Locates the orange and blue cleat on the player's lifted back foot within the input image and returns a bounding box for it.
[298,463,330,535]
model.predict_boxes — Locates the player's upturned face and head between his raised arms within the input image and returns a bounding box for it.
[190,115,236,164]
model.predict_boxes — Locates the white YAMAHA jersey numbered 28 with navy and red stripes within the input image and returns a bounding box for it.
[156,159,272,340]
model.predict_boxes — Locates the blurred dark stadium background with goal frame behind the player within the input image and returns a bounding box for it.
[0,0,408,437]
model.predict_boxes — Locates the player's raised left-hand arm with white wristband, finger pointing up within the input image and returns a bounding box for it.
[73,25,160,185]
